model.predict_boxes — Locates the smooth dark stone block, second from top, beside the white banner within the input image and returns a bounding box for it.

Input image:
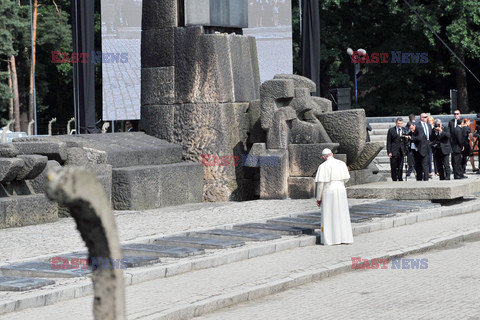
[142,28,175,68]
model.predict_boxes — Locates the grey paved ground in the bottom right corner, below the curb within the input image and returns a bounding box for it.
[197,242,480,320]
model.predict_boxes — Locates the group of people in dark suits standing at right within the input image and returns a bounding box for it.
[387,110,470,181]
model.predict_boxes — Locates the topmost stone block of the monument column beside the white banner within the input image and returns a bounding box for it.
[142,0,178,30]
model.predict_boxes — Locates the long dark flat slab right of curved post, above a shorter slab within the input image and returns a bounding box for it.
[122,243,205,258]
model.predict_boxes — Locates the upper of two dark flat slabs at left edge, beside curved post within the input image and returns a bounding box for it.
[0,261,91,278]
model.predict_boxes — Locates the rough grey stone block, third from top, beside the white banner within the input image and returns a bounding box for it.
[141,66,175,105]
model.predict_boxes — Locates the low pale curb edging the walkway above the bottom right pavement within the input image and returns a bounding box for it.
[142,229,480,320]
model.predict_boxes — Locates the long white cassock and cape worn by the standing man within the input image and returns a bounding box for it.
[315,157,353,245]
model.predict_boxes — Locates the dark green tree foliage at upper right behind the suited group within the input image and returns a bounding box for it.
[293,0,480,116]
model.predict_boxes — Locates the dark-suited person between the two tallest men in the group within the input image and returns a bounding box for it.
[430,119,452,180]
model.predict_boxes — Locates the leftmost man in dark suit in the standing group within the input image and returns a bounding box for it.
[387,118,405,181]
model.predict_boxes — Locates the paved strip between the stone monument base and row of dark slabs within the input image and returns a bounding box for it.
[0,199,342,265]
